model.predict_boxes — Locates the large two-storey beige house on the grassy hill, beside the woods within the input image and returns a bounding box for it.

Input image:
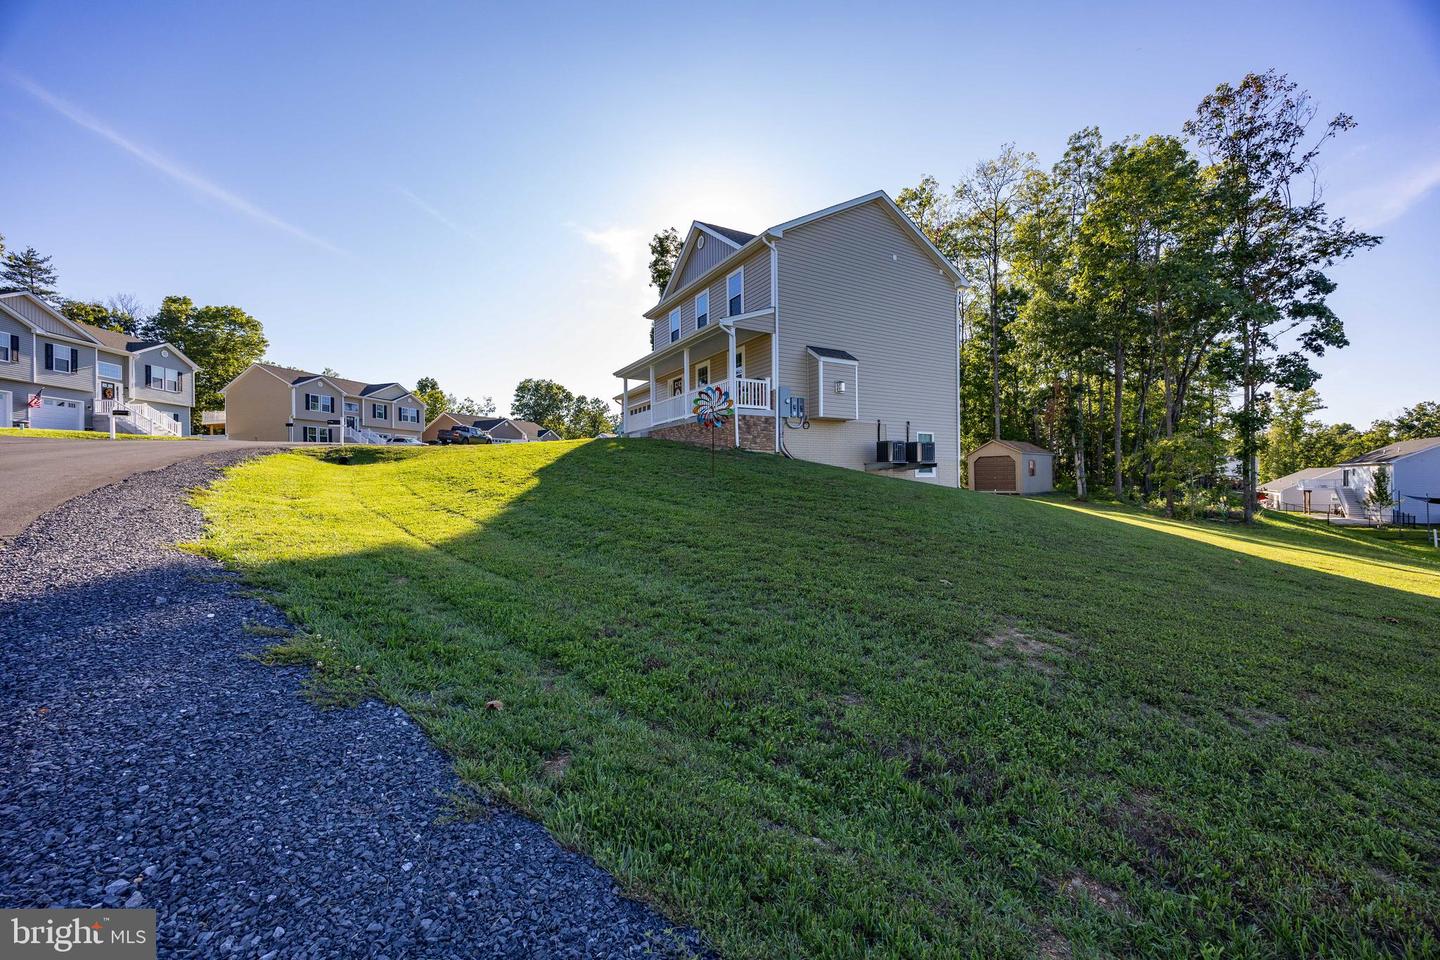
[615,191,965,486]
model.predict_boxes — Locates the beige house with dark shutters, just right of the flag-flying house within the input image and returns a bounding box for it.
[220,363,425,443]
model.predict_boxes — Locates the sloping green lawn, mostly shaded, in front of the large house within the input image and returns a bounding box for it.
[199,440,1440,959]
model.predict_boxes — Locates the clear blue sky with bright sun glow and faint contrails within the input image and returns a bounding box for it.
[0,0,1440,423]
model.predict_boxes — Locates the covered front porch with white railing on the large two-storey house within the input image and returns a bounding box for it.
[616,317,775,449]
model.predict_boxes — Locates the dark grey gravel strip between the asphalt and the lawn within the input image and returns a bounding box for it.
[0,450,698,959]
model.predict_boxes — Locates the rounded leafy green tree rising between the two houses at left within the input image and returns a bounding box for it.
[140,296,269,429]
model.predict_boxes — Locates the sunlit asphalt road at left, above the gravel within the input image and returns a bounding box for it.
[0,436,284,540]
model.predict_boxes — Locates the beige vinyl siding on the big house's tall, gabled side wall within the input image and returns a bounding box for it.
[771,201,959,486]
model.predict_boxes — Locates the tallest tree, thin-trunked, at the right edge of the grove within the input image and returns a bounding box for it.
[1185,71,1380,521]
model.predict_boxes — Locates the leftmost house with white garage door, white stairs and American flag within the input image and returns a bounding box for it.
[0,292,196,436]
